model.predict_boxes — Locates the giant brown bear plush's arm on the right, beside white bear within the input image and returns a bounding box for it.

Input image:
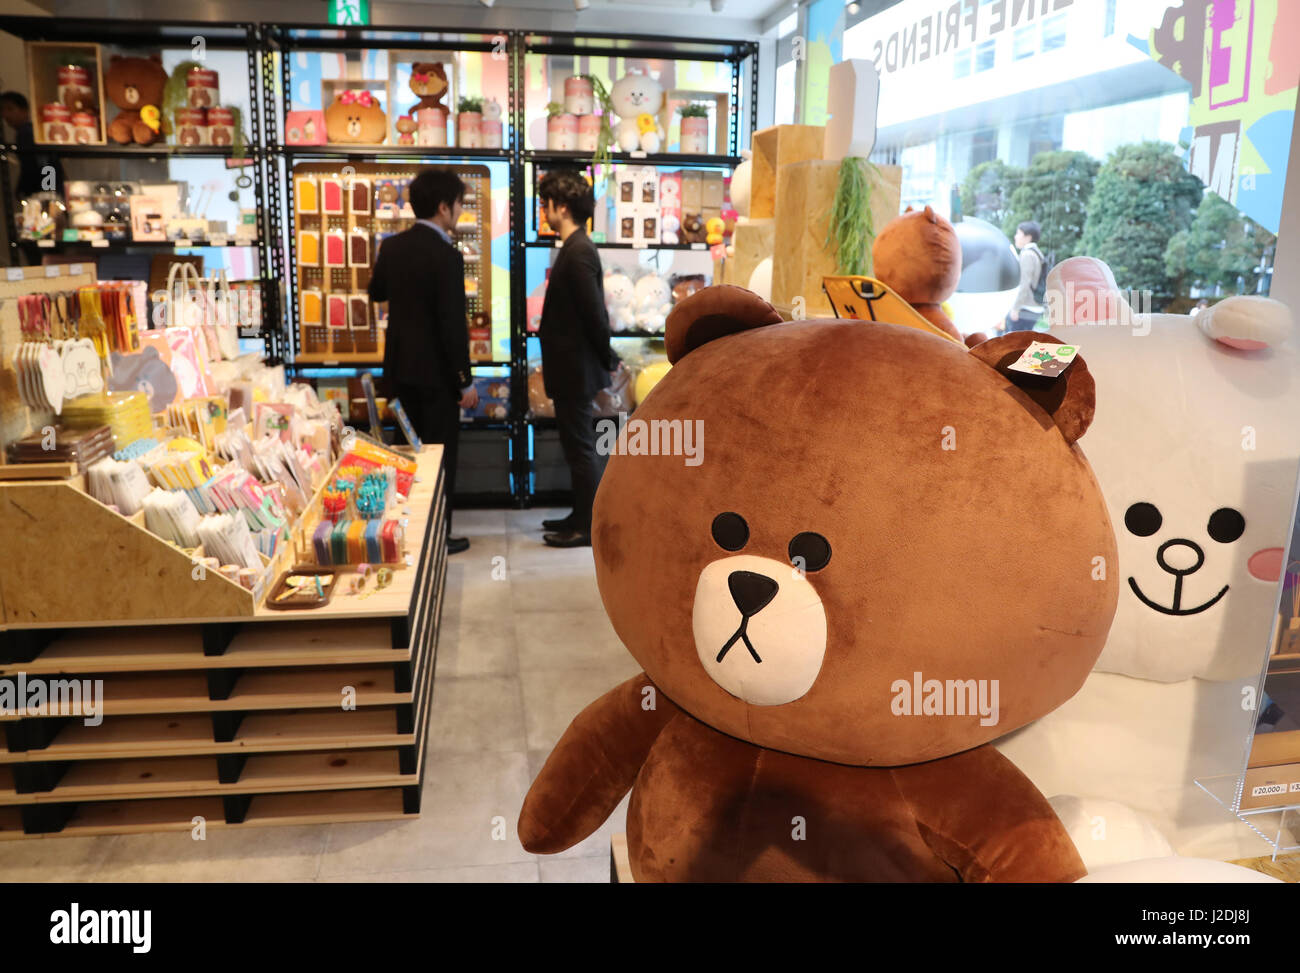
[893,745,1087,882]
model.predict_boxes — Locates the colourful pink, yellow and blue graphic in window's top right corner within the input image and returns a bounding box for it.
[1151,0,1300,233]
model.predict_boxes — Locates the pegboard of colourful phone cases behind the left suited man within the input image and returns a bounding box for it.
[293,163,491,362]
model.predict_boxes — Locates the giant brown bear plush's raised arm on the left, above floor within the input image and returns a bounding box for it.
[519,673,681,855]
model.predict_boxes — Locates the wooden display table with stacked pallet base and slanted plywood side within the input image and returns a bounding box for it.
[0,446,446,839]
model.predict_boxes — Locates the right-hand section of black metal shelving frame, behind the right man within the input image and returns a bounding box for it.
[511,31,758,506]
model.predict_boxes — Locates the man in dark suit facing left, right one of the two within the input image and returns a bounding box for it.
[537,170,616,548]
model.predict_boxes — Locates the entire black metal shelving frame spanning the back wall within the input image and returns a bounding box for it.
[0,17,758,507]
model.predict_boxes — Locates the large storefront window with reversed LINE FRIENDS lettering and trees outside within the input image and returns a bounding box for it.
[842,0,1297,311]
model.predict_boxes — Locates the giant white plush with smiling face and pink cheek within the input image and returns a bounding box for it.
[996,258,1300,859]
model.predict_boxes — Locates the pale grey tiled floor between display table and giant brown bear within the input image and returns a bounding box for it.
[0,510,638,882]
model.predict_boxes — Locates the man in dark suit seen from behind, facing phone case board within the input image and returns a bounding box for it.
[369,168,478,554]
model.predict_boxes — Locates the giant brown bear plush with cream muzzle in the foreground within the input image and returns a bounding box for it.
[519,286,1117,882]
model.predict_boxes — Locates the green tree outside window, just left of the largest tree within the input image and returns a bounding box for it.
[1001,152,1101,260]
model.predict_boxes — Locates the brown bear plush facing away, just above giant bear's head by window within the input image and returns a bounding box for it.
[871,206,962,341]
